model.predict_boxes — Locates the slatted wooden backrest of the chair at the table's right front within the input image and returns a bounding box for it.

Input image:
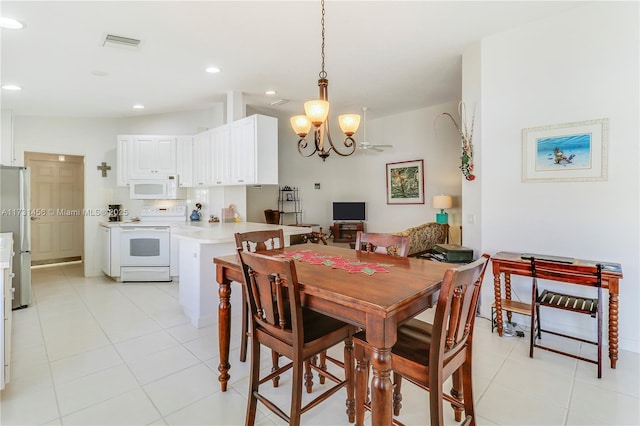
[429,254,489,368]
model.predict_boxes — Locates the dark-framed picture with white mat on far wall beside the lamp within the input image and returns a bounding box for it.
[387,160,424,204]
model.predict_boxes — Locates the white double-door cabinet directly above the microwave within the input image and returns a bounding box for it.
[131,136,177,179]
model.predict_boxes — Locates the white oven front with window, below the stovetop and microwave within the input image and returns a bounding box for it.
[120,222,171,281]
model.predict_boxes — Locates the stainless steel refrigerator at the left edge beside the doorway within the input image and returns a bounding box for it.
[0,165,31,309]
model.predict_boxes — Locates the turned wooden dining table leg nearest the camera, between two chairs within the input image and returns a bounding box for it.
[371,348,393,426]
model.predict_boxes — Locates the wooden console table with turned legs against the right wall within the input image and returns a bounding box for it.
[491,252,622,368]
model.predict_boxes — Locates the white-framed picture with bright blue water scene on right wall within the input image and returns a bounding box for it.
[522,118,609,182]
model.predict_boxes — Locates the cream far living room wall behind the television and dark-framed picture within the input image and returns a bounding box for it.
[276,102,461,241]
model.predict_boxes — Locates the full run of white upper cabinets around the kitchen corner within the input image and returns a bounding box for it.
[117,115,278,187]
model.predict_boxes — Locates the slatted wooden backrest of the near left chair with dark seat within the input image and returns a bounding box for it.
[238,249,304,348]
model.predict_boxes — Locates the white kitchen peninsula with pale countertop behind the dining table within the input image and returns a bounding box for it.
[171,222,311,328]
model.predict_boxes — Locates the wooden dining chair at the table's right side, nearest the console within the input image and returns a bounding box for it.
[353,254,489,425]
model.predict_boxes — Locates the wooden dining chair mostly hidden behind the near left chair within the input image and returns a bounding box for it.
[235,229,284,372]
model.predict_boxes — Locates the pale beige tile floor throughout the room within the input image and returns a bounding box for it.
[0,264,640,425]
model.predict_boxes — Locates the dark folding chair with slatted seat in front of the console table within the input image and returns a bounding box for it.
[529,256,602,379]
